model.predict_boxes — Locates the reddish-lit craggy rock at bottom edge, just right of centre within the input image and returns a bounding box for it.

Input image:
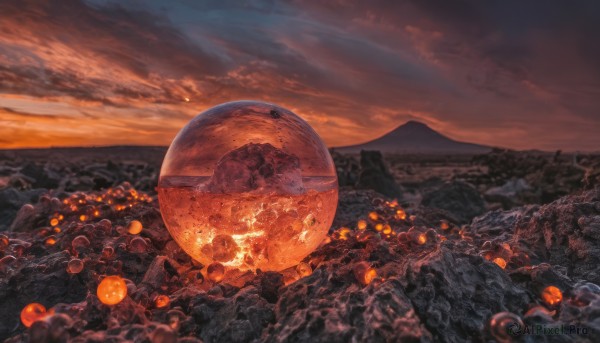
[265,267,431,342]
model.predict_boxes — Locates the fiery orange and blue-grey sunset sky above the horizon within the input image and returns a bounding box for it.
[0,0,600,151]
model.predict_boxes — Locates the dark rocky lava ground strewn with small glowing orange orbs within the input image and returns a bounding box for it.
[0,148,600,342]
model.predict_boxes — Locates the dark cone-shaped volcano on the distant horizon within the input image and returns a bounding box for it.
[335,120,492,154]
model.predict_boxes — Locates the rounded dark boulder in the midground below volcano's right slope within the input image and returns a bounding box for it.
[421,181,485,223]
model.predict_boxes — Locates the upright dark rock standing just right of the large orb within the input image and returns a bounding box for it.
[356,151,402,198]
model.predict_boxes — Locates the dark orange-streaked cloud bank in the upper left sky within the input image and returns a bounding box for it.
[0,0,225,105]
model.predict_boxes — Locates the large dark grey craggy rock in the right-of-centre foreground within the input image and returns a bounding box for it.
[403,248,531,342]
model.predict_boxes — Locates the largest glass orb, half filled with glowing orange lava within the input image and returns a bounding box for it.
[158,101,338,270]
